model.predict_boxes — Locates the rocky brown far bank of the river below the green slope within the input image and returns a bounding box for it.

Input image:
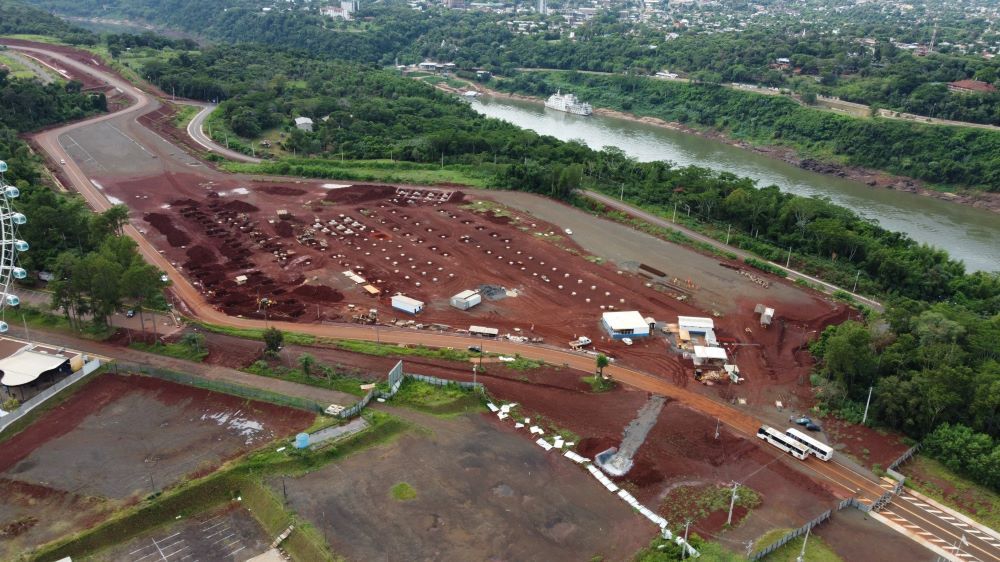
[452,83,1000,213]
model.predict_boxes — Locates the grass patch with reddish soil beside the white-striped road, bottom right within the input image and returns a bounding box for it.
[900,455,1000,529]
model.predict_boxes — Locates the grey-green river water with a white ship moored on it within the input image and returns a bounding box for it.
[472,96,1000,271]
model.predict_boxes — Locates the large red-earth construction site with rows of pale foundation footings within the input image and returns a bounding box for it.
[99,174,849,412]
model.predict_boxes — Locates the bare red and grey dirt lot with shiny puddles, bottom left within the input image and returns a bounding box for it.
[0,374,314,560]
